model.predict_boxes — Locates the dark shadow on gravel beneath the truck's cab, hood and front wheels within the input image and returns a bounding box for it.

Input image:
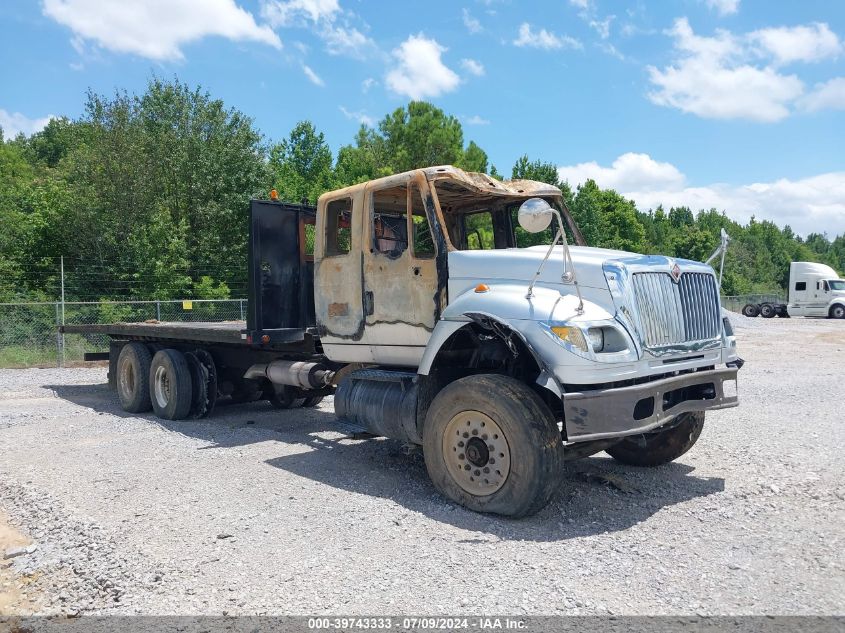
[266,436,725,542]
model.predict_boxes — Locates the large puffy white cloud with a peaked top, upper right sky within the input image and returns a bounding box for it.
[648,18,804,122]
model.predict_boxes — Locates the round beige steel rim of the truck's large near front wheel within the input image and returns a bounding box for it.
[442,411,511,497]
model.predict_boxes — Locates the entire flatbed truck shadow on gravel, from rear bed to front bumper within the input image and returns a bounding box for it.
[45,384,725,542]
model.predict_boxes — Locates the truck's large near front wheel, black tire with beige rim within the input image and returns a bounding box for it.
[423,374,563,517]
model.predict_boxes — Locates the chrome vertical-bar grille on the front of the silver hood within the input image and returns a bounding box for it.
[632,273,721,347]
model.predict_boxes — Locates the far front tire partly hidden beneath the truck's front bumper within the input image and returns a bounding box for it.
[606,411,704,466]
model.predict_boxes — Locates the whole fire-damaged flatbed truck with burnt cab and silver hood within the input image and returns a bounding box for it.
[64,166,742,517]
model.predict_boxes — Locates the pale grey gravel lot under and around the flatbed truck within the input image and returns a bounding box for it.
[0,316,845,614]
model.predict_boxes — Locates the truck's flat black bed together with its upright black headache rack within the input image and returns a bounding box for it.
[59,200,317,360]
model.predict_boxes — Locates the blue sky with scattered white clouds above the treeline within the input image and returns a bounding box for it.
[0,0,845,237]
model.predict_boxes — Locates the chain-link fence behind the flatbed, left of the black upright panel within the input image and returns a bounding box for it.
[0,299,247,367]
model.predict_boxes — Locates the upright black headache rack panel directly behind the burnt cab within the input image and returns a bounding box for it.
[244,200,317,346]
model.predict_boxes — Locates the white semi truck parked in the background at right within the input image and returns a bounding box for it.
[742,262,845,319]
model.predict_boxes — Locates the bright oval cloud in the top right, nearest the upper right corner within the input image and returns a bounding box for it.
[748,22,843,64]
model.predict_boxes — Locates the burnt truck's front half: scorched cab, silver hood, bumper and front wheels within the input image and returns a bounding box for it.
[314,166,742,515]
